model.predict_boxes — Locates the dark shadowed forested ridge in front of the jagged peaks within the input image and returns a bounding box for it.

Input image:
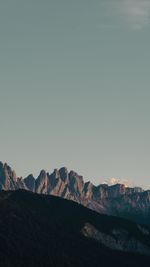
[0,190,150,267]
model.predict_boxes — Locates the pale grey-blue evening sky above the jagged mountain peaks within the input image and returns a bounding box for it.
[0,0,150,188]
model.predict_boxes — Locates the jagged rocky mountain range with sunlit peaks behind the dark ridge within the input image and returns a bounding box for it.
[0,162,150,225]
